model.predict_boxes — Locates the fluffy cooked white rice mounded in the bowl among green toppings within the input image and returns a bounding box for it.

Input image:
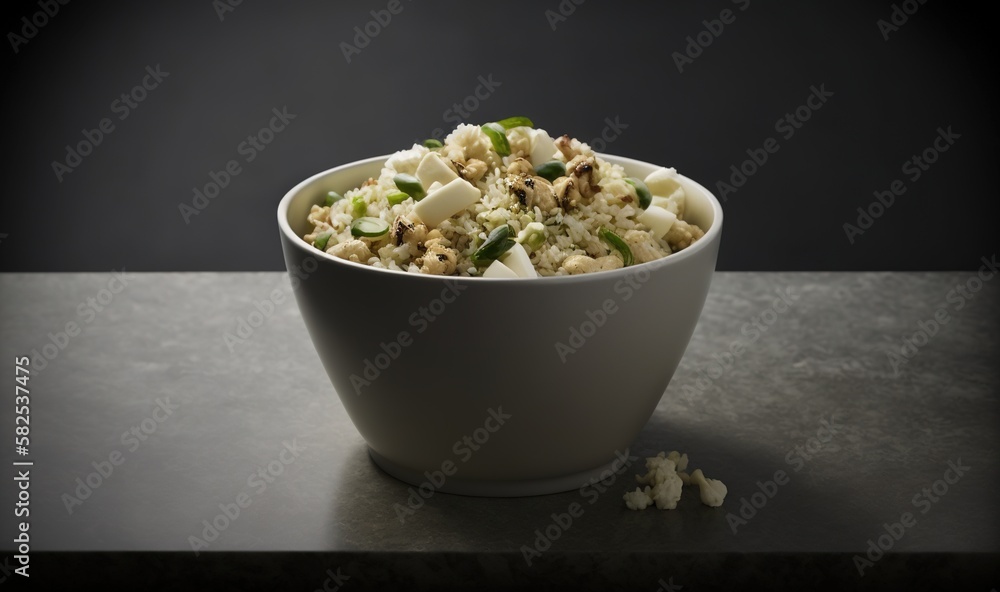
[303,124,703,276]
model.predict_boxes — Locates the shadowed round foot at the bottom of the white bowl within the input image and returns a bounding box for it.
[368,447,617,497]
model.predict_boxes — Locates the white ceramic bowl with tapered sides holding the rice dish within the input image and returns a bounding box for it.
[278,155,722,496]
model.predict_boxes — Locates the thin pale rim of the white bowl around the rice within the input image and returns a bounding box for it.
[278,152,722,285]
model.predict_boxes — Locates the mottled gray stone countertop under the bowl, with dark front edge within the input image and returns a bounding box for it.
[0,272,1000,592]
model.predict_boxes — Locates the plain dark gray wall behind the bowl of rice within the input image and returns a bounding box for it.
[0,0,998,271]
